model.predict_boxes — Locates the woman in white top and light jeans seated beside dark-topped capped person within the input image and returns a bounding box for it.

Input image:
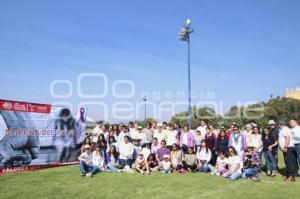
[223,146,242,180]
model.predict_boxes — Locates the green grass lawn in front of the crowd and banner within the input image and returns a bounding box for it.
[0,160,300,199]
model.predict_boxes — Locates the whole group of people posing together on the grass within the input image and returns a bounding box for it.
[78,119,300,182]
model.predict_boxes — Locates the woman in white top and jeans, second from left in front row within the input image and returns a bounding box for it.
[86,145,105,177]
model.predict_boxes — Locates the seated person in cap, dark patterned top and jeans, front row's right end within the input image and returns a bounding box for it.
[242,142,261,181]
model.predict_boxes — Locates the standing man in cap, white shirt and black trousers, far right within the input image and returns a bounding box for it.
[278,120,298,182]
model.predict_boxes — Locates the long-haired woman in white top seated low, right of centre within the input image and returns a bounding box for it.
[197,140,211,173]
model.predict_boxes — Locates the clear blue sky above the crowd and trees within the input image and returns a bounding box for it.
[0,0,300,121]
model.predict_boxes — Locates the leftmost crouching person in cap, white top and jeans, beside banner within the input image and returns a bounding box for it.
[78,144,92,176]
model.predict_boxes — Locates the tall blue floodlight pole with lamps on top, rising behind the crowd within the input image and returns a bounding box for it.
[179,19,193,129]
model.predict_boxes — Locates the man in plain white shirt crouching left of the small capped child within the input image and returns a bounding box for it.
[119,135,134,168]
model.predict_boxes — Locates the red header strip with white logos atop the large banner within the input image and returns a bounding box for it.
[0,99,51,113]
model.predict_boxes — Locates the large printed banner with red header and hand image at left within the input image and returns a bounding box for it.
[0,100,86,173]
